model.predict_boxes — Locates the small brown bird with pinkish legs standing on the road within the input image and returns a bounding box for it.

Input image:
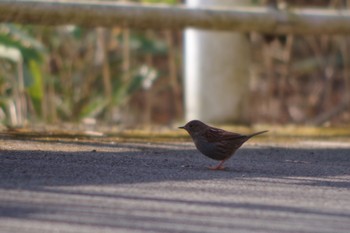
[179,120,267,170]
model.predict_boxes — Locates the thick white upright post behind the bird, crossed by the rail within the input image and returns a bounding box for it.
[184,0,250,122]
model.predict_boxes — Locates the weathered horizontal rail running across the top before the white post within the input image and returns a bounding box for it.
[0,0,350,34]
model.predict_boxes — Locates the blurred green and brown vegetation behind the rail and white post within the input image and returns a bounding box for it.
[0,0,350,130]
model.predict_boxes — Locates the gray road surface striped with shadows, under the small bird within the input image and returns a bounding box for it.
[0,138,350,233]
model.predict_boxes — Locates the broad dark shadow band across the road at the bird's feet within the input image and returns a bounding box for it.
[0,139,350,188]
